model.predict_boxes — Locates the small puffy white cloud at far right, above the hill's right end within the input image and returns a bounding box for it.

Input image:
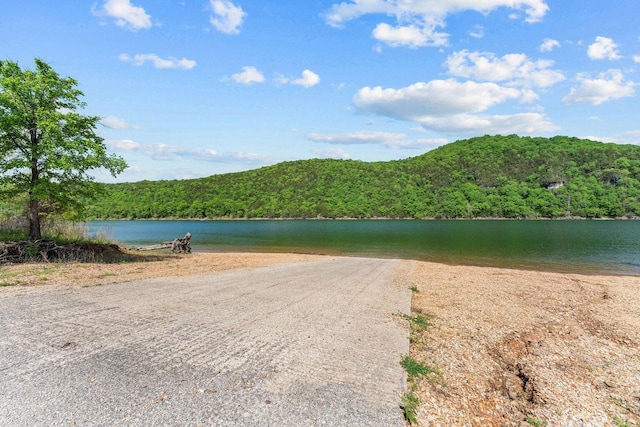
[562,69,636,105]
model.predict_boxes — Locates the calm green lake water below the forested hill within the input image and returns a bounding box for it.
[89,220,640,275]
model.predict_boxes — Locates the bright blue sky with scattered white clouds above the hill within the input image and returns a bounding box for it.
[0,0,640,182]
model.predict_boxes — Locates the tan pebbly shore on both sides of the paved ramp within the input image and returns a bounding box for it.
[0,253,640,426]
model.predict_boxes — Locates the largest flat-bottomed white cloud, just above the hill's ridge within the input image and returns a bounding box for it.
[353,79,556,133]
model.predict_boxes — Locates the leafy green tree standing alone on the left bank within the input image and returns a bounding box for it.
[0,59,127,240]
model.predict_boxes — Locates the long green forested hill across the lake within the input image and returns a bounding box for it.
[88,135,640,218]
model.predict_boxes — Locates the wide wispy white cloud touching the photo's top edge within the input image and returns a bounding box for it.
[324,0,549,48]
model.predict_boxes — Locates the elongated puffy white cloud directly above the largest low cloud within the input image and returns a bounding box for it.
[446,50,565,87]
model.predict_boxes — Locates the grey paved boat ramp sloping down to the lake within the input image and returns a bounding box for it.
[0,257,411,426]
